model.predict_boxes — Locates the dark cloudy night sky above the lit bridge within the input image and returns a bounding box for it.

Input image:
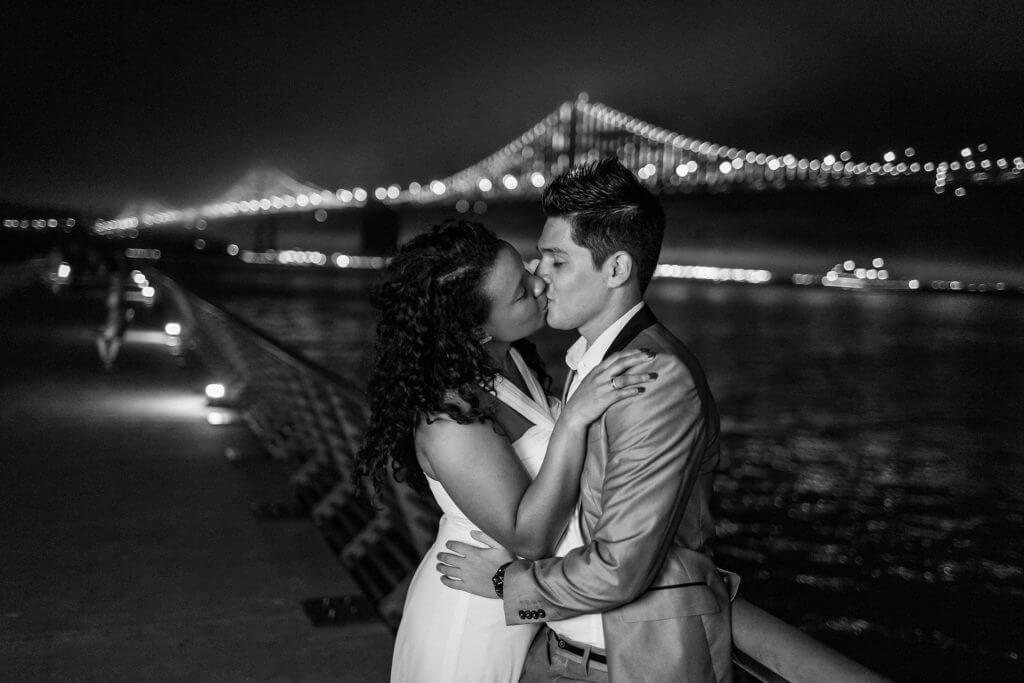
[0,0,1024,212]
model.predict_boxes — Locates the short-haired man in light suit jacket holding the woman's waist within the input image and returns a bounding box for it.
[438,159,738,683]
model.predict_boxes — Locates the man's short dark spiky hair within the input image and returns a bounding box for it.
[543,157,665,292]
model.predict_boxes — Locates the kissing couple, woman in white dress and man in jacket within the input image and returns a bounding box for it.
[357,159,738,683]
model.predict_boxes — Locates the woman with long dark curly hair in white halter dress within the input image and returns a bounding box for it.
[356,222,652,683]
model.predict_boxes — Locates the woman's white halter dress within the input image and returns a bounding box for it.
[391,349,580,683]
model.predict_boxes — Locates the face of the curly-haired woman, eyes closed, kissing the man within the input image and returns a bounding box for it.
[483,242,548,342]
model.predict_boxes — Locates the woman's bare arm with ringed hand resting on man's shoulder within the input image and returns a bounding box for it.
[416,351,653,559]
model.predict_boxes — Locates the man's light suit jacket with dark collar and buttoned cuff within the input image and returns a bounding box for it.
[504,306,738,683]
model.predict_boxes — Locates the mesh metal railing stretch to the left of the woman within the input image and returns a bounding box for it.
[154,272,440,629]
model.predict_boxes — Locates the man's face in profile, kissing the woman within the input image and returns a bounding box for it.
[535,217,608,330]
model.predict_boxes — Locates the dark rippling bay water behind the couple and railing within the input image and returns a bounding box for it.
[193,273,1024,681]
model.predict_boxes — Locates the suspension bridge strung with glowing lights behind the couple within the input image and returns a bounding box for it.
[93,94,1024,237]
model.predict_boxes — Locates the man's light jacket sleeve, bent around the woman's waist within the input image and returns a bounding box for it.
[504,353,708,625]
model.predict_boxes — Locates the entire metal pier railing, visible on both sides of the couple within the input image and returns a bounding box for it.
[154,273,886,683]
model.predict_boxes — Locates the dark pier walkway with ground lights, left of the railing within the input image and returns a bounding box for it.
[0,280,393,681]
